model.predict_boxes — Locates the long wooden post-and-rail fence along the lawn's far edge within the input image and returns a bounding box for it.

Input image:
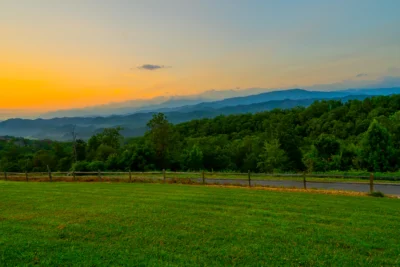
[0,172,400,195]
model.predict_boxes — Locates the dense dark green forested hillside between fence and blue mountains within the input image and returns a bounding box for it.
[0,95,400,172]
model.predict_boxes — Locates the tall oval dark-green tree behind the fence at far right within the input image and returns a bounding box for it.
[361,119,394,172]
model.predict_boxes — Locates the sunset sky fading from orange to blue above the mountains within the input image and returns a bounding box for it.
[0,0,400,116]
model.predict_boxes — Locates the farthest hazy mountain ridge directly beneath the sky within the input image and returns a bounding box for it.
[38,87,398,119]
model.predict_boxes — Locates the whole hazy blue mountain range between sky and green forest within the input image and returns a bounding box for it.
[0,87,400,140]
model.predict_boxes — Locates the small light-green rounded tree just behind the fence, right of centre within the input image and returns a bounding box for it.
[257,139,288,173]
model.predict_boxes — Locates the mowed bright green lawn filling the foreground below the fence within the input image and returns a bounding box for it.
[0,182,400,266]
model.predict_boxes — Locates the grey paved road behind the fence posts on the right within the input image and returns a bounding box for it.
[184,179,400,196]
